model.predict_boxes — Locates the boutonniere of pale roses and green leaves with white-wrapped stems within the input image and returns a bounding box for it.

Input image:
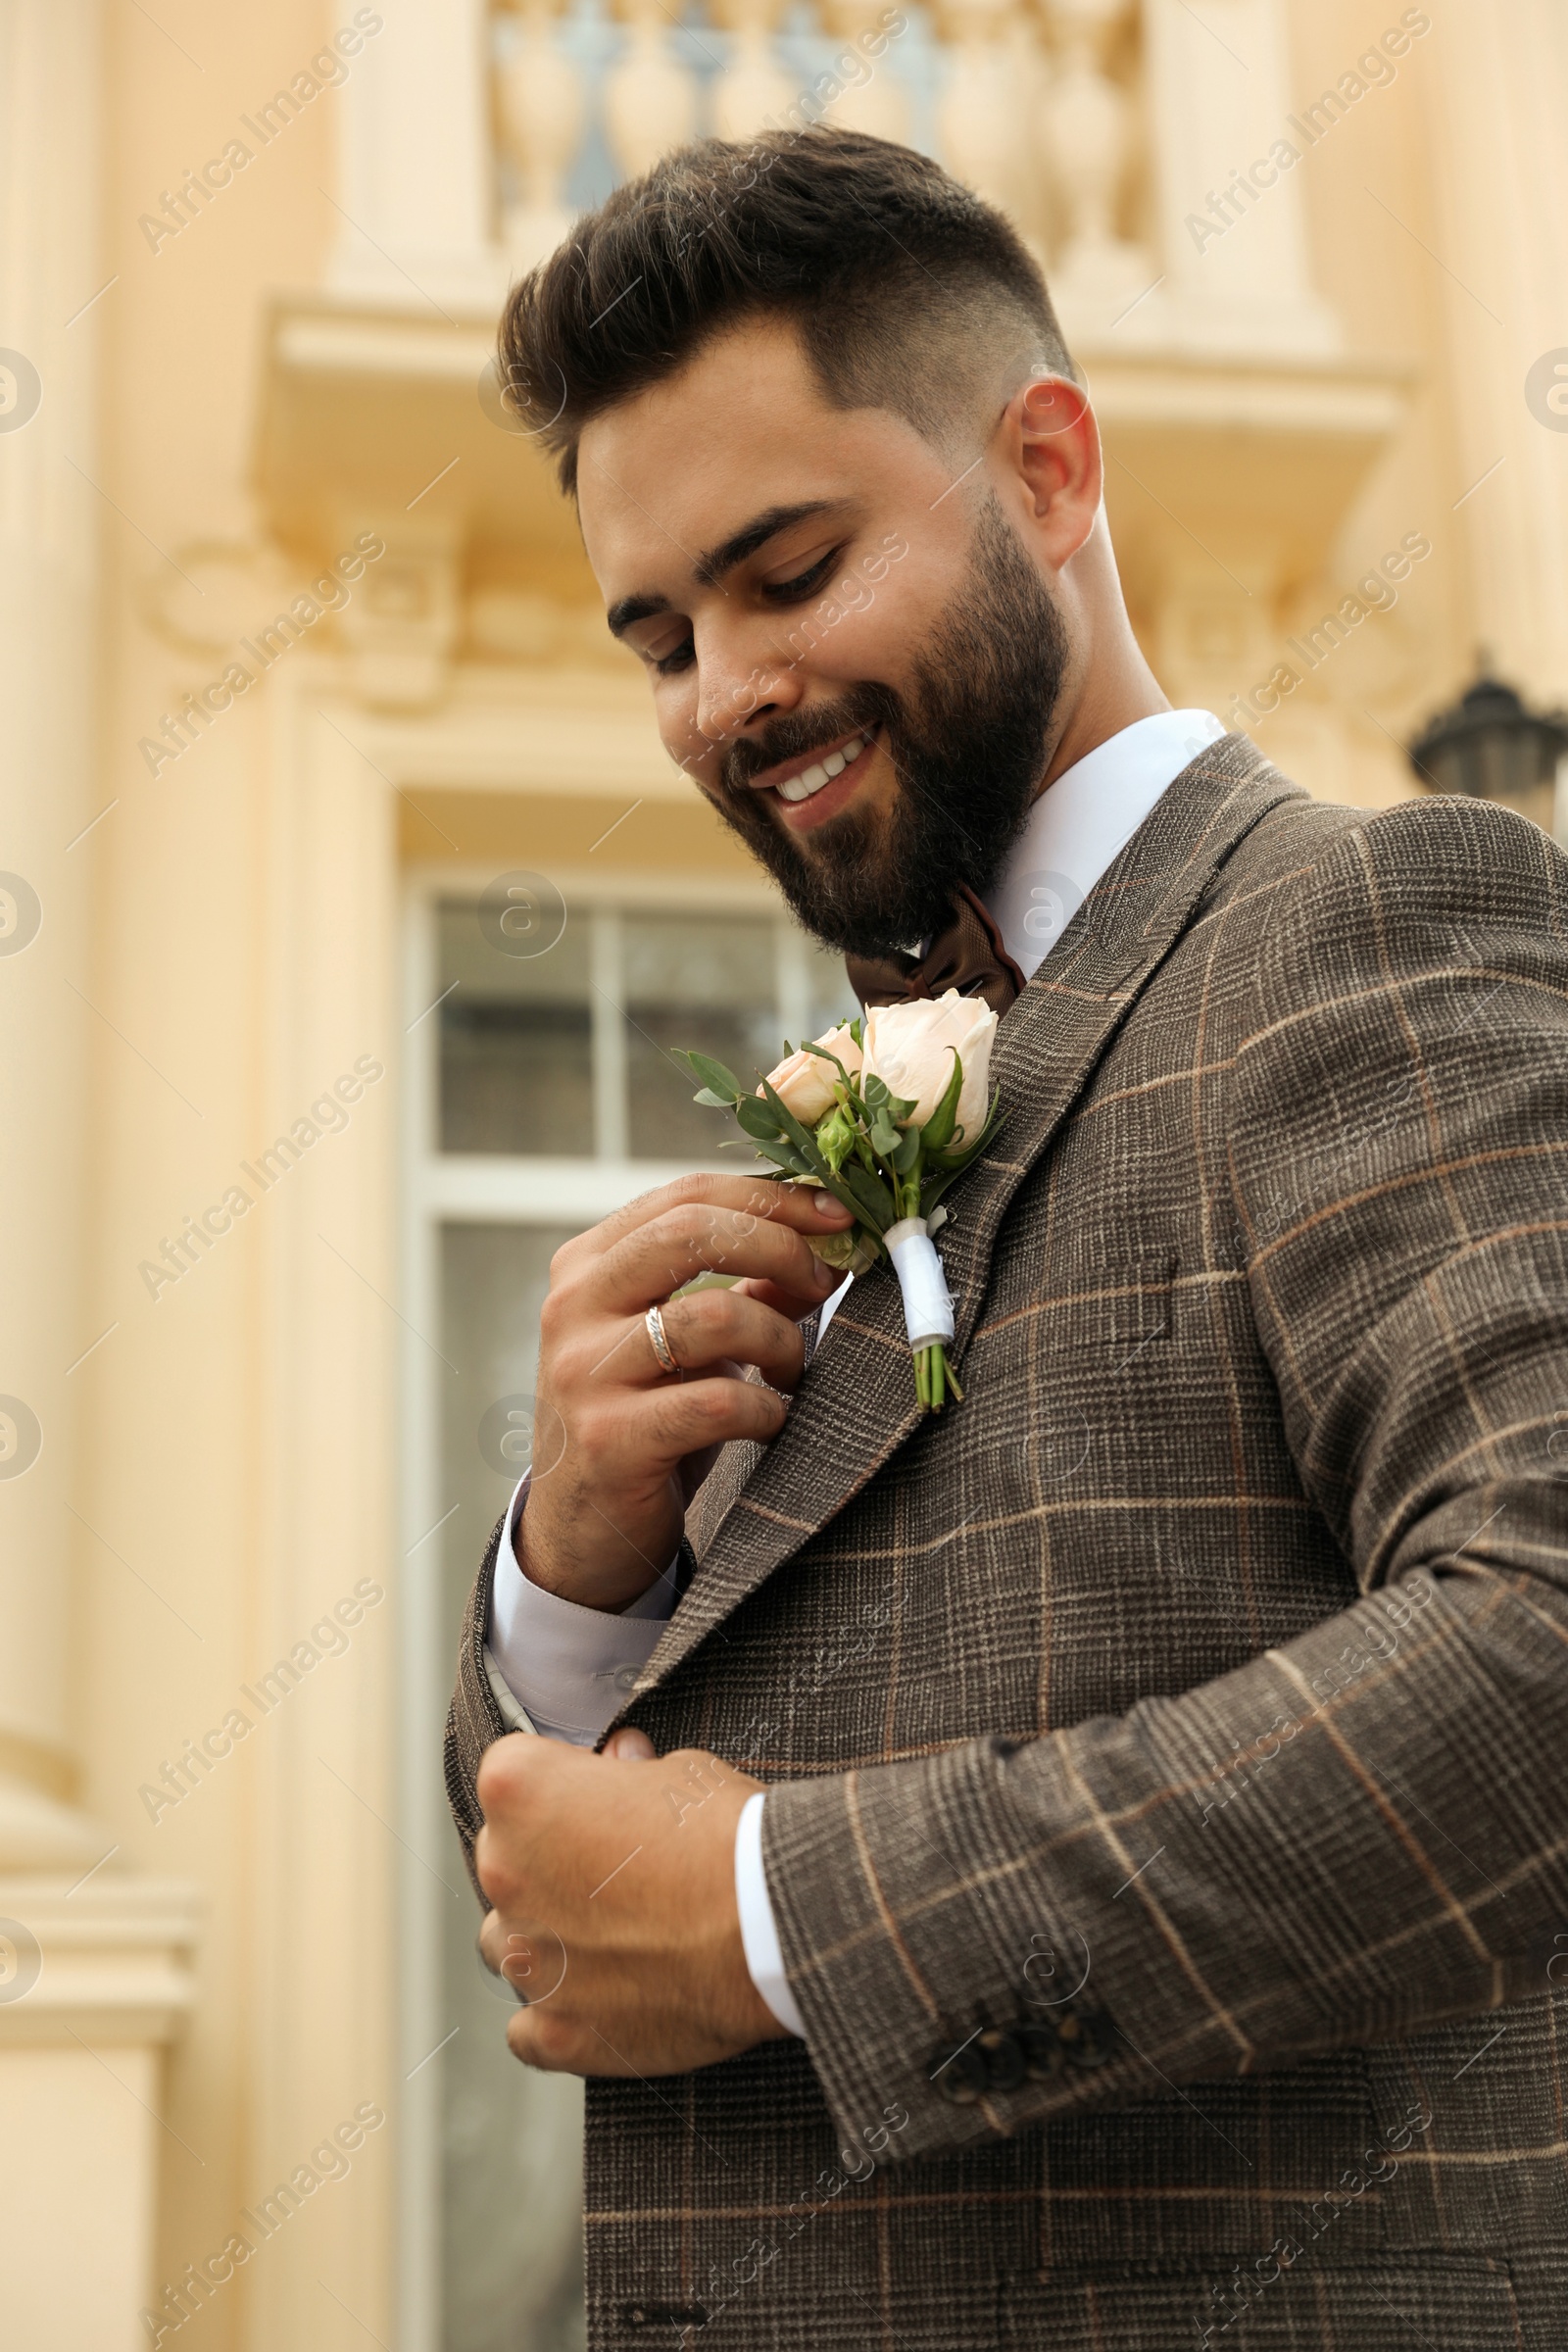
[679,988,1002,1413]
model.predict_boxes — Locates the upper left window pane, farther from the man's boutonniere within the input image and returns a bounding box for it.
[437,901,592,1154]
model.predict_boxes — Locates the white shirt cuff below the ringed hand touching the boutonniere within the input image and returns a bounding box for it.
[484,1477,679,1747]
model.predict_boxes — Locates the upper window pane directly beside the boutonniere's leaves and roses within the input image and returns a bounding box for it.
[620,915,783,1164]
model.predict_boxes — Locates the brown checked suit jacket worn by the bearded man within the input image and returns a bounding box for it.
[447,736,1568,2352]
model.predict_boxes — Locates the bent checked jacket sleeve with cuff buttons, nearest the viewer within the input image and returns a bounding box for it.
[764,802,1568,2157]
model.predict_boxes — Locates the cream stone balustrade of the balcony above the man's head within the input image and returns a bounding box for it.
[489,0,1156,341]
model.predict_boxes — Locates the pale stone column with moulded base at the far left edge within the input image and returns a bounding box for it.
[0,0,190,2352]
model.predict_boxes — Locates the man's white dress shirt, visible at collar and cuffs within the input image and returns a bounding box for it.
[484,710,1225,2034]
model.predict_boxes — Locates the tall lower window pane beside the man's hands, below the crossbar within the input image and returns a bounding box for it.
[441,1225,585,2352]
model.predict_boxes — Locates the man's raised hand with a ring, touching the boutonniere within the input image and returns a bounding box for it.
[517,1176,851,1609]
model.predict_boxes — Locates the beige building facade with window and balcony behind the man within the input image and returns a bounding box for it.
[0,0,1568,2352]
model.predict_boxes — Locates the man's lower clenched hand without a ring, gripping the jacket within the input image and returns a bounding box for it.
[475,1731,783,2075]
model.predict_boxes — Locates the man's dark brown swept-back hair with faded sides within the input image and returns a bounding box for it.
[499,127,1072,492]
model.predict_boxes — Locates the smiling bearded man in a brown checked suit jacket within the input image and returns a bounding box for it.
[449,131,1568,2352]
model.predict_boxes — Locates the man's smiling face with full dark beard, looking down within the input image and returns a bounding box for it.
[578,322,1067,953]
